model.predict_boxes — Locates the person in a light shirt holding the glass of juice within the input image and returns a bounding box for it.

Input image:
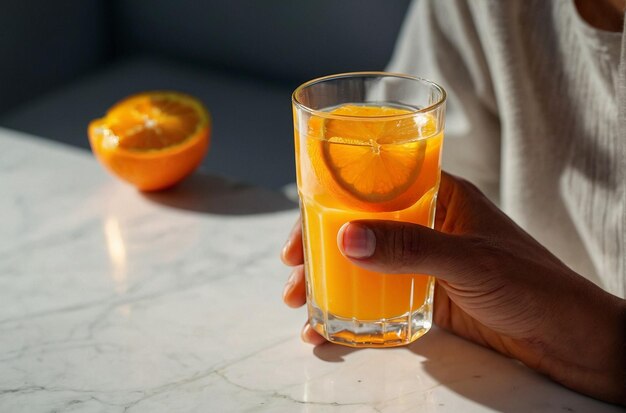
[282,0,626,405]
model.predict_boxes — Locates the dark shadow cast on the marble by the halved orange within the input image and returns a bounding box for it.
[143,172,298,215]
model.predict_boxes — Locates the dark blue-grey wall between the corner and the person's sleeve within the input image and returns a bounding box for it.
[114,0,409,83]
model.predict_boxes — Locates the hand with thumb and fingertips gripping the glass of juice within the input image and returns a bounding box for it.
[282,173,626,404]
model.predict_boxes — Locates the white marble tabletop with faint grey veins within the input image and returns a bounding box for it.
[0,129,620,413]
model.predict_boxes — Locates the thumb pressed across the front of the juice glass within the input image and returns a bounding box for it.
[337,220,473,282]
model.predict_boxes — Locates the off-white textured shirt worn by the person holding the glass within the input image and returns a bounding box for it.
[388,0,626,297]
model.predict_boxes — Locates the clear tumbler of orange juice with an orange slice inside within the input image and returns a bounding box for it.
[292,72,446,347]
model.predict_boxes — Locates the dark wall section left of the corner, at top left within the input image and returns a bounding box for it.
[0,0,110,112]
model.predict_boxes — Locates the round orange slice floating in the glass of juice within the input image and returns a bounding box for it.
[309,104,435,212]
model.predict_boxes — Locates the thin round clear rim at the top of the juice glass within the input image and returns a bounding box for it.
[291,71,448,120]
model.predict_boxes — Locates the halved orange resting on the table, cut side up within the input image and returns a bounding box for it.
[88,91,211,191]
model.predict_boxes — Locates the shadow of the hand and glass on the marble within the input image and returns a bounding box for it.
[313,328,604,412]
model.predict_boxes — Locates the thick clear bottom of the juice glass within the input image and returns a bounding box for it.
[308,287,432,347]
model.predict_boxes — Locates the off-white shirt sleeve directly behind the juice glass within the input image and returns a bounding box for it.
[387,0,501,203]
